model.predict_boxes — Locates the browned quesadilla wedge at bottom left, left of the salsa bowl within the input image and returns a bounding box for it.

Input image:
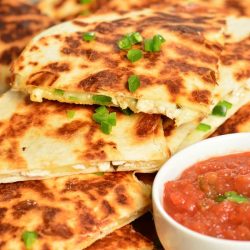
[0,172,151,250]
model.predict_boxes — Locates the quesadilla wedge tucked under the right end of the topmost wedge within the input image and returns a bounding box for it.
[163,38,250,154]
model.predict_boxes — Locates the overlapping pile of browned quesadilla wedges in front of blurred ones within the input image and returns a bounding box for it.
[0,1,250,250]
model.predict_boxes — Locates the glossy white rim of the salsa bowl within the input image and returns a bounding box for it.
[152,132,250,247]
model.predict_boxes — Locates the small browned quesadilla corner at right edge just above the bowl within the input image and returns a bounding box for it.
[211,103,250,137]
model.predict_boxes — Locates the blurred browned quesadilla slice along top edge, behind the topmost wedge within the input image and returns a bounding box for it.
[38,0,250,20]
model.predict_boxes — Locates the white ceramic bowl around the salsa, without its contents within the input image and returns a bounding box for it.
[153,133,250,250]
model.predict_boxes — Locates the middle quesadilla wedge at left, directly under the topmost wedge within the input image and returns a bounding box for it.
[0,91,168,182]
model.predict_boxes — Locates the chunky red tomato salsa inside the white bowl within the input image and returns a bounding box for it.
[164,152,250,240]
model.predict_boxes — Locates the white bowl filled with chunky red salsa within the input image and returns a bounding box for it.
[153,133,250,250]
